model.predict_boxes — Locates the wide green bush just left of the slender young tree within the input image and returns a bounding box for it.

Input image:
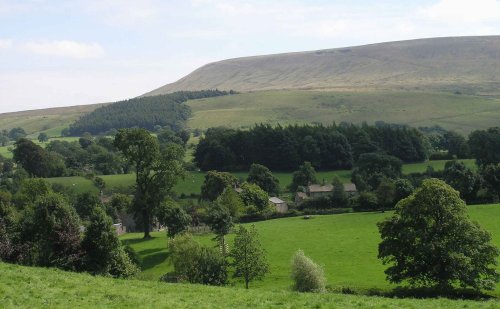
[170,235,227,285]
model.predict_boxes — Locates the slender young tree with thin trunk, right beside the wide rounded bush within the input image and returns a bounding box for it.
[231,225,269,289]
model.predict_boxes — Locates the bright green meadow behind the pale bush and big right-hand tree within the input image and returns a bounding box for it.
[121,204,500,296]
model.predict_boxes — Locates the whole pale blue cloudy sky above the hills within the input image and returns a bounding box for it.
[0,0,500,113]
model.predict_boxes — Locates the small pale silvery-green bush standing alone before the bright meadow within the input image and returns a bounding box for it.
[292,250,326,292]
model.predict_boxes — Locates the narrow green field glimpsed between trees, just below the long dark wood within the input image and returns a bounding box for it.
[43,160,475,195]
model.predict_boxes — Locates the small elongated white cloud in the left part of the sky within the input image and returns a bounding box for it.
[22,40,104,59]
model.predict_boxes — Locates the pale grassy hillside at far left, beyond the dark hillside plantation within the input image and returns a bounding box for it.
[0,104,103,138]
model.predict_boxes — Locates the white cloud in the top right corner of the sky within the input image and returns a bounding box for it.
[420,0,500,23]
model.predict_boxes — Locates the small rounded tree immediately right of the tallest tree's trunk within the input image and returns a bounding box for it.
[157,199,191,238]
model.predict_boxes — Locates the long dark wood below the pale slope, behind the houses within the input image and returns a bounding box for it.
[194,124,428,171]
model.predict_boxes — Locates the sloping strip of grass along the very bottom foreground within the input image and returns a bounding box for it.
[0,263,498,308]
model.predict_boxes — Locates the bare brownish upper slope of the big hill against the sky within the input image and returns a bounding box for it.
[145,36,500,95]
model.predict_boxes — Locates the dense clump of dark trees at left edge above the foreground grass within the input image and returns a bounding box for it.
[0,179,139,278]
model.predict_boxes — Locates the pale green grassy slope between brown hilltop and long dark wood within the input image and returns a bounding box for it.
[188,90,500,134]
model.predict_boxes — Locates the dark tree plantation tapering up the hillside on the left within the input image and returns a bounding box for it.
[68,90,229,136]
